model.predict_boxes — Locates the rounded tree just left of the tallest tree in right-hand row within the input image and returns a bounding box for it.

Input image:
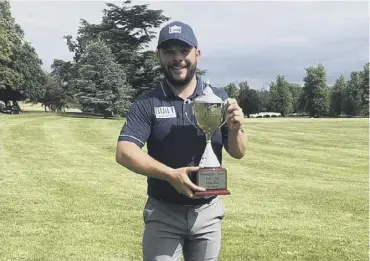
[270,75,293,117]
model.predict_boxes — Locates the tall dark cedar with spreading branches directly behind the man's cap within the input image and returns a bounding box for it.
[65,1,169,98]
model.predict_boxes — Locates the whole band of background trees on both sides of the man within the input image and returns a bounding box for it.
[0,0,369,117]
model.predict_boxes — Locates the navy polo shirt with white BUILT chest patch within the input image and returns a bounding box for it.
[118,77,228,205]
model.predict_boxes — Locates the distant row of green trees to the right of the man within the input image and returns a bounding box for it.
[223,63,369,117]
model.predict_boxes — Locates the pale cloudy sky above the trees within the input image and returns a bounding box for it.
[10,0,369,89]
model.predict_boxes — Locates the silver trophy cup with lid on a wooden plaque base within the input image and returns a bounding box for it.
[186,81,231,197]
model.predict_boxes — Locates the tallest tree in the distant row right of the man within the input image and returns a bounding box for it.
[301,64,329,117]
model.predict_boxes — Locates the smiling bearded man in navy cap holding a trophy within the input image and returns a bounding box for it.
[116,22,246,261]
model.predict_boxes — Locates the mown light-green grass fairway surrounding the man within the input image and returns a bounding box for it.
[0,112,369,261]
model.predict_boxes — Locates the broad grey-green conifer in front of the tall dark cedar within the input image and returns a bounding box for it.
[73,41,132,118]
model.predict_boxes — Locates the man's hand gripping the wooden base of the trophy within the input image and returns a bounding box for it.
[168,167,206,198]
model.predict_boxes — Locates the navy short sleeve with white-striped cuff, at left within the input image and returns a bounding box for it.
[118,100,152,148]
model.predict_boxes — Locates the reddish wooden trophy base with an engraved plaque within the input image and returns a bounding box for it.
[192,167,231,197]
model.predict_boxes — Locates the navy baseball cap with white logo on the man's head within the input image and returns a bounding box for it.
[157,21,198,48]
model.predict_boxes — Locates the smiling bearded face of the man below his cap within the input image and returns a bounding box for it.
[159,40,200,87]
